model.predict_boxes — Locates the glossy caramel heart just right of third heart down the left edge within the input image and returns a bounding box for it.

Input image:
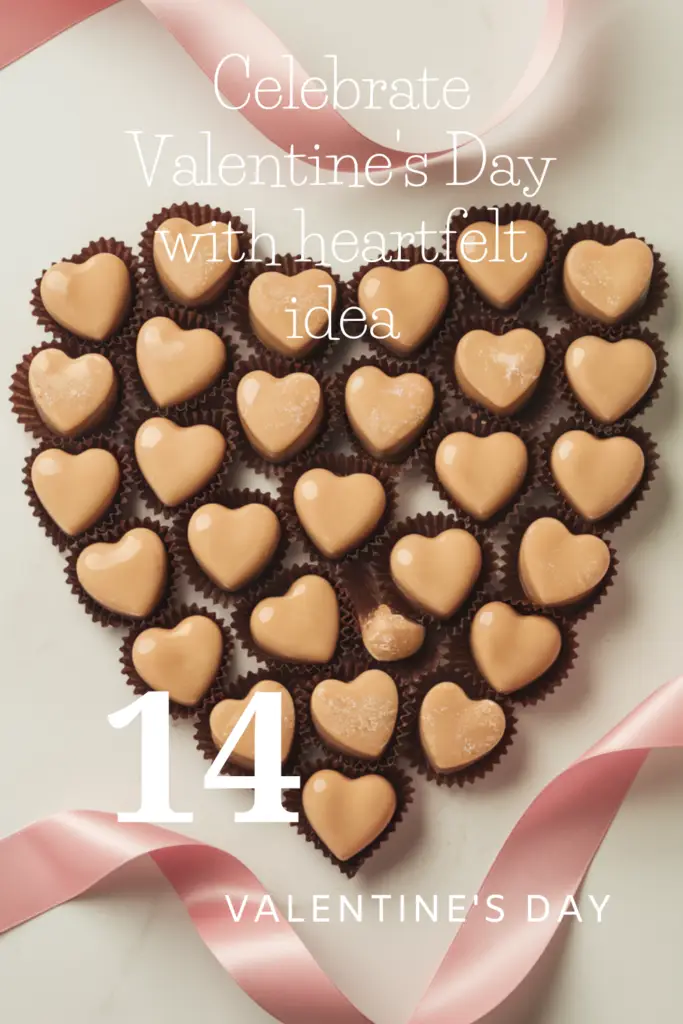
[135,416,225,508]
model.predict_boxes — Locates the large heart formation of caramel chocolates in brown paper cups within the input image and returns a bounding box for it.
[12,208,664,873]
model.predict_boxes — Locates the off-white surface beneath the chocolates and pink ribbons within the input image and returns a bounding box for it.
[0,0,683,1024]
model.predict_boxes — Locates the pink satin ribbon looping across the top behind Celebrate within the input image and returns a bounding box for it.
[0,0,565,166]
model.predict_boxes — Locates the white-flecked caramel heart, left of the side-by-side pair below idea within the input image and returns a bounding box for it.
[237,370,325,462]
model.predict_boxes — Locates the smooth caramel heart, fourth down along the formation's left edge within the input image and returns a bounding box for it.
[76,526,168,618]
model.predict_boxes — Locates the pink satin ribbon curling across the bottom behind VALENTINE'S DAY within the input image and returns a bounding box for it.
[0,677,683,1024]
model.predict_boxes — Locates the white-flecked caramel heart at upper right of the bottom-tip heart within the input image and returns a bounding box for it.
[420,682,506,775]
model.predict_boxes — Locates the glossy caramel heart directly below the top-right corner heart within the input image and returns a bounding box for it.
[564,336,657,423]
